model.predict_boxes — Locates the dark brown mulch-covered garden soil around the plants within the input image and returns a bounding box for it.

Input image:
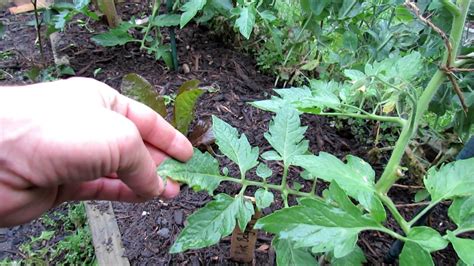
[0,3,466,265]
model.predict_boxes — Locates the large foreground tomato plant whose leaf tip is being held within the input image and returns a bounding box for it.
[157,0,474,265]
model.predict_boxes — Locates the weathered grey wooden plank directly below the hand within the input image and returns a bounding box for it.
[85,201,130,266]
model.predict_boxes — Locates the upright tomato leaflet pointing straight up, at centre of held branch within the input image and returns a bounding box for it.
[264,108,308,167]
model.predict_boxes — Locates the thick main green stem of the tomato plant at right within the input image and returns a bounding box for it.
[376,0,470,194]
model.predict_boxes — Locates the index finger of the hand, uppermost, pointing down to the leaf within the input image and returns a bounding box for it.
[111,91,193,161]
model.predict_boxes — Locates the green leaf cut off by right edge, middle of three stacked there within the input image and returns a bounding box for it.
[448,196,474,230]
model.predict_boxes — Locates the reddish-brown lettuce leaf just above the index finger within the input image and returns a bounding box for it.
[120,73,167,117]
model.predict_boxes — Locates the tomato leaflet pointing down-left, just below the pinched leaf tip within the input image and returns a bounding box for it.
[170,194,253,253]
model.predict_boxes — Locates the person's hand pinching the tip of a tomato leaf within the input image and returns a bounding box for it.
[0,78,193,227]
